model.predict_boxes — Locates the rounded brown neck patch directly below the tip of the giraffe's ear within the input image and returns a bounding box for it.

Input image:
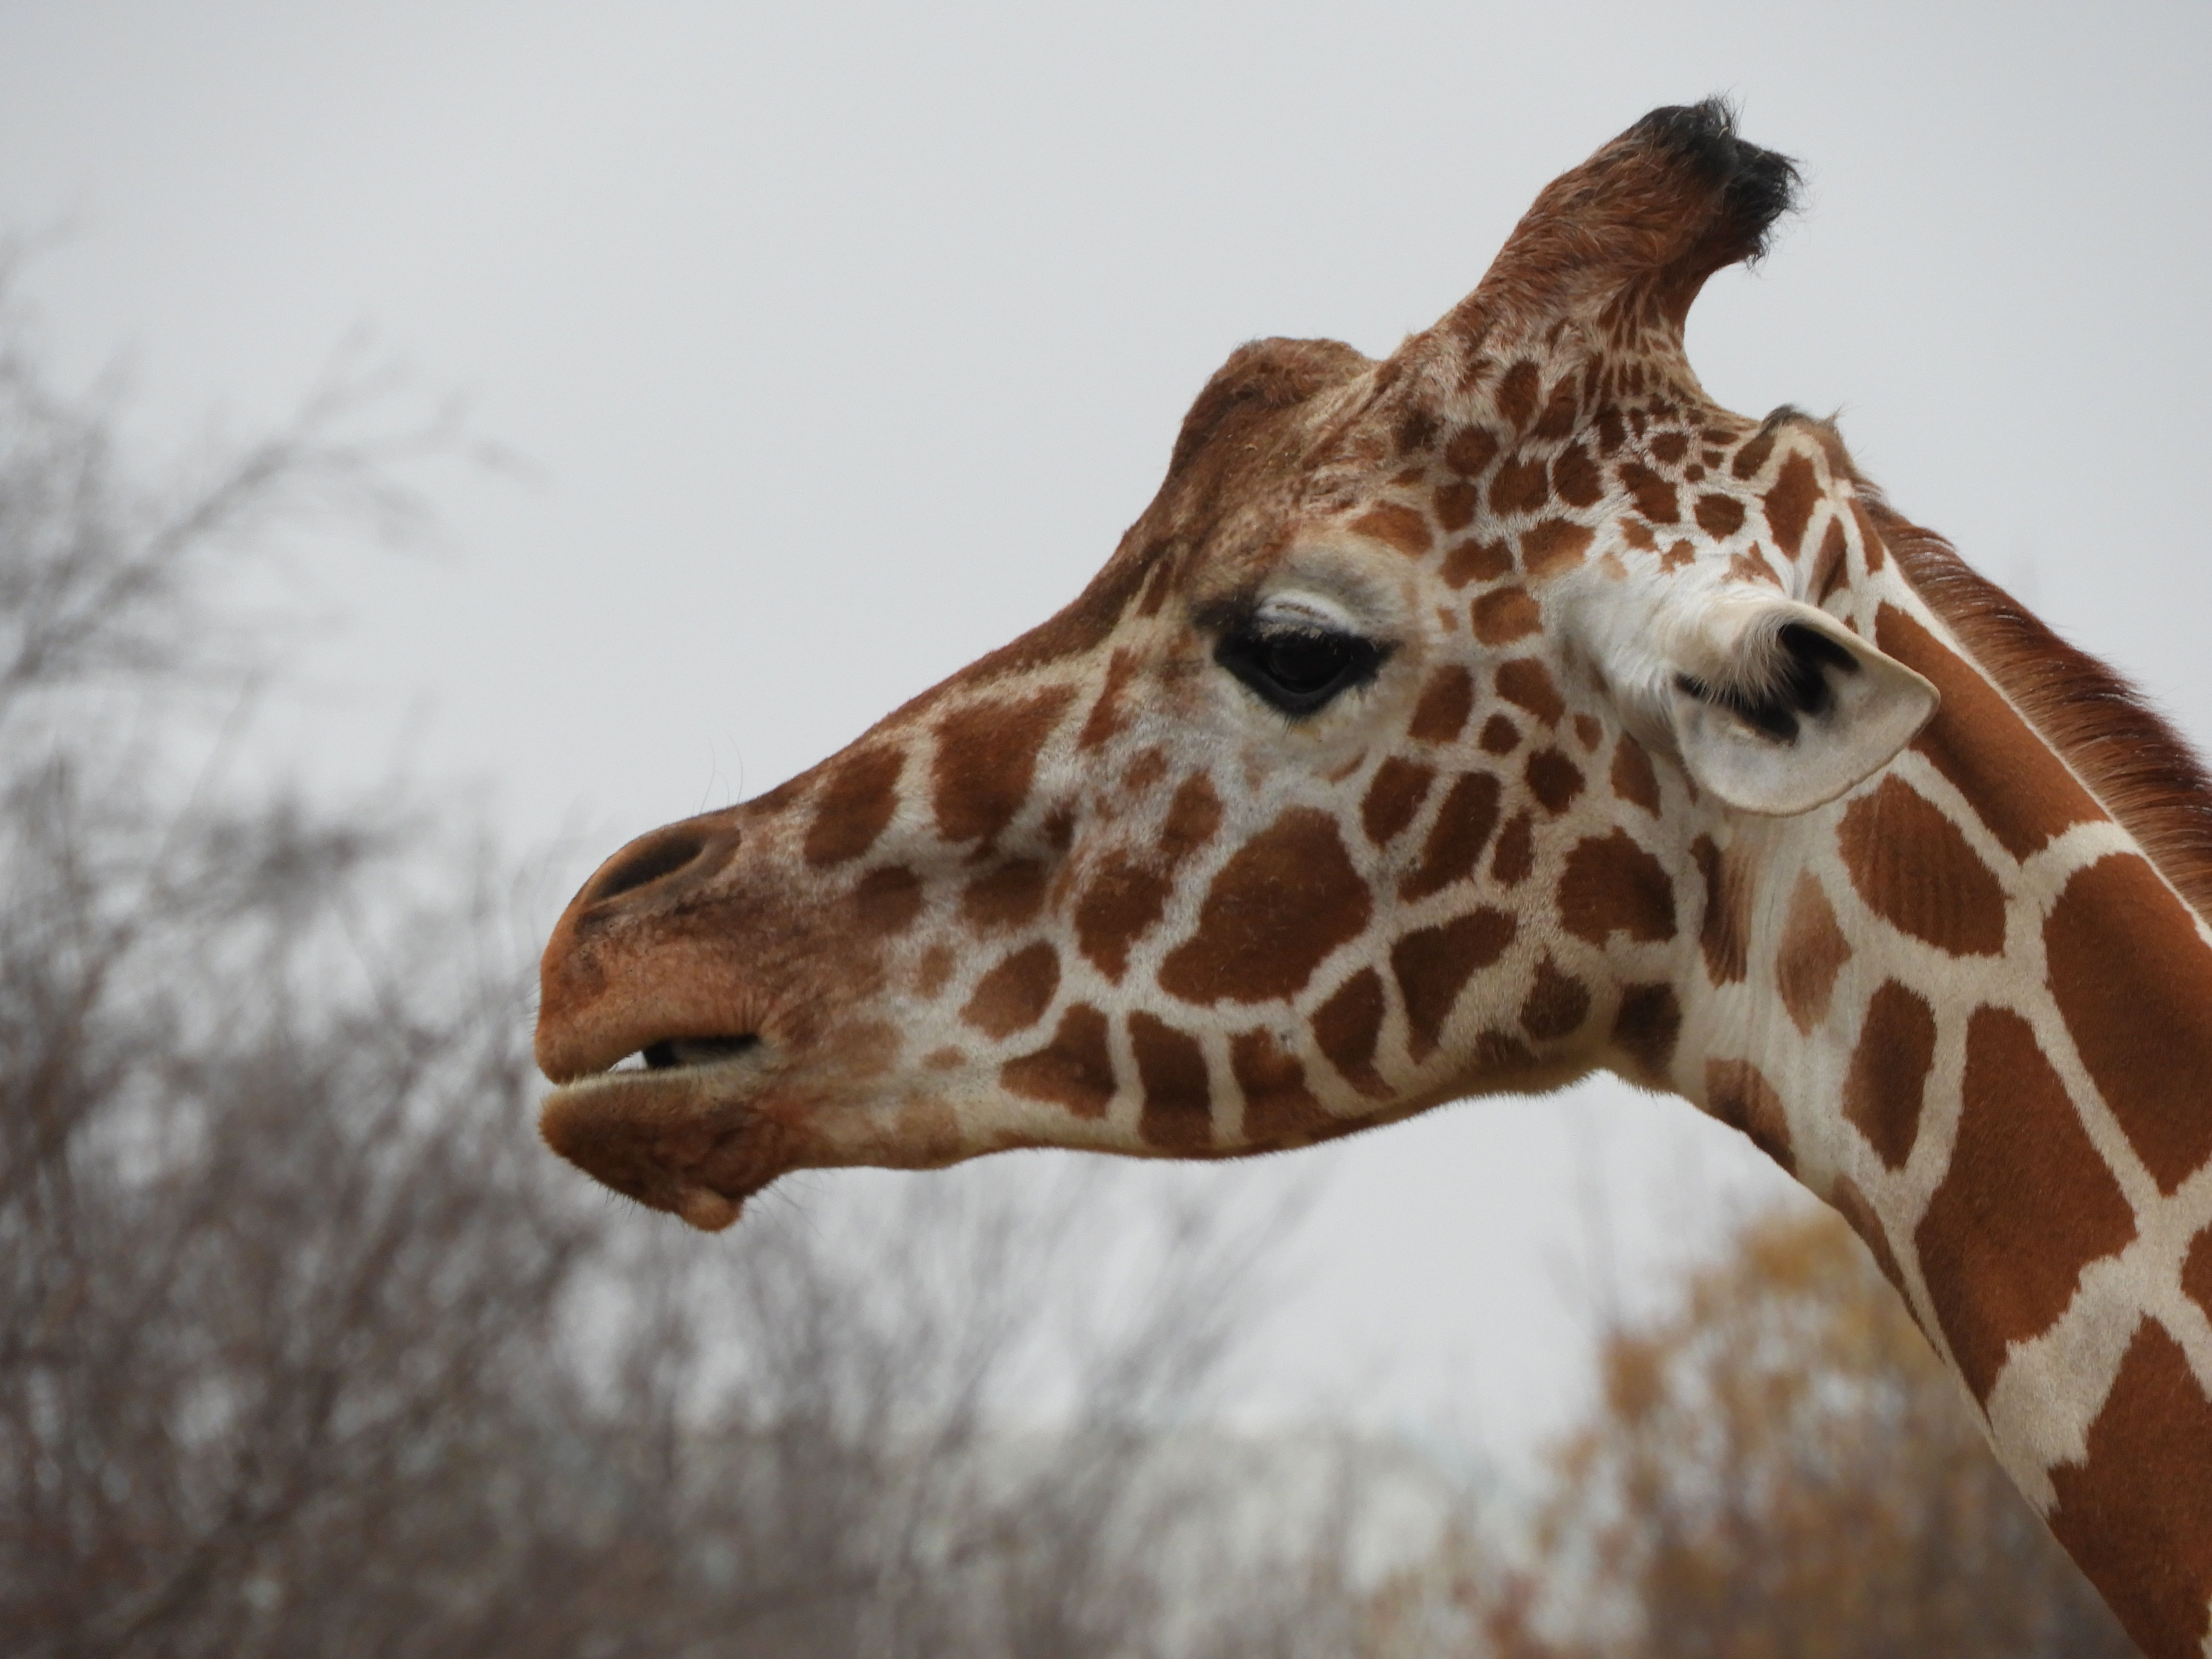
[1836,777,2004,955]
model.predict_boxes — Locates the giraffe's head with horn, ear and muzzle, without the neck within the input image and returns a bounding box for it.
[538,104,1936,1228]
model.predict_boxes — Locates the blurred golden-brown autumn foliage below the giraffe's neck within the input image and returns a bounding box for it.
[1376,1208,2135,1659]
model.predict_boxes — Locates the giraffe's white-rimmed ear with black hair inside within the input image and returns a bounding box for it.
[1668,597,1940,816]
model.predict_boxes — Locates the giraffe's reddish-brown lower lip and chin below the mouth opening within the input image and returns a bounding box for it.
[538,1068,805,1232]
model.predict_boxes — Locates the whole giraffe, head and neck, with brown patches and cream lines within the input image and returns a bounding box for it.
[538,99,2212,1659]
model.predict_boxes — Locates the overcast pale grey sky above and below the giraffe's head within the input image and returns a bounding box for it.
[0,0,2212,1460]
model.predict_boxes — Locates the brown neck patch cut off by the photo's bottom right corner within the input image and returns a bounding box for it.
[2051,1318,2212,1655]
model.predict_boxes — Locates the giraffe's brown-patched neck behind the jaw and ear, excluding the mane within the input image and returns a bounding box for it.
[1676,584,2212,1652]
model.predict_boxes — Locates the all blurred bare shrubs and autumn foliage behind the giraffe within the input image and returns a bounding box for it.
[0,292,2130,1659]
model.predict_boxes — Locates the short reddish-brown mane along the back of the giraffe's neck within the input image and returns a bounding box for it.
[1867,491,2212,920]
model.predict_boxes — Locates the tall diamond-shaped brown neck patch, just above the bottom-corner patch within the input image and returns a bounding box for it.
[1913,1009,2135,1400]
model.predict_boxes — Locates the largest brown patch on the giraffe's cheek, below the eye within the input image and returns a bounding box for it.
[1159,807,1374,1004]
